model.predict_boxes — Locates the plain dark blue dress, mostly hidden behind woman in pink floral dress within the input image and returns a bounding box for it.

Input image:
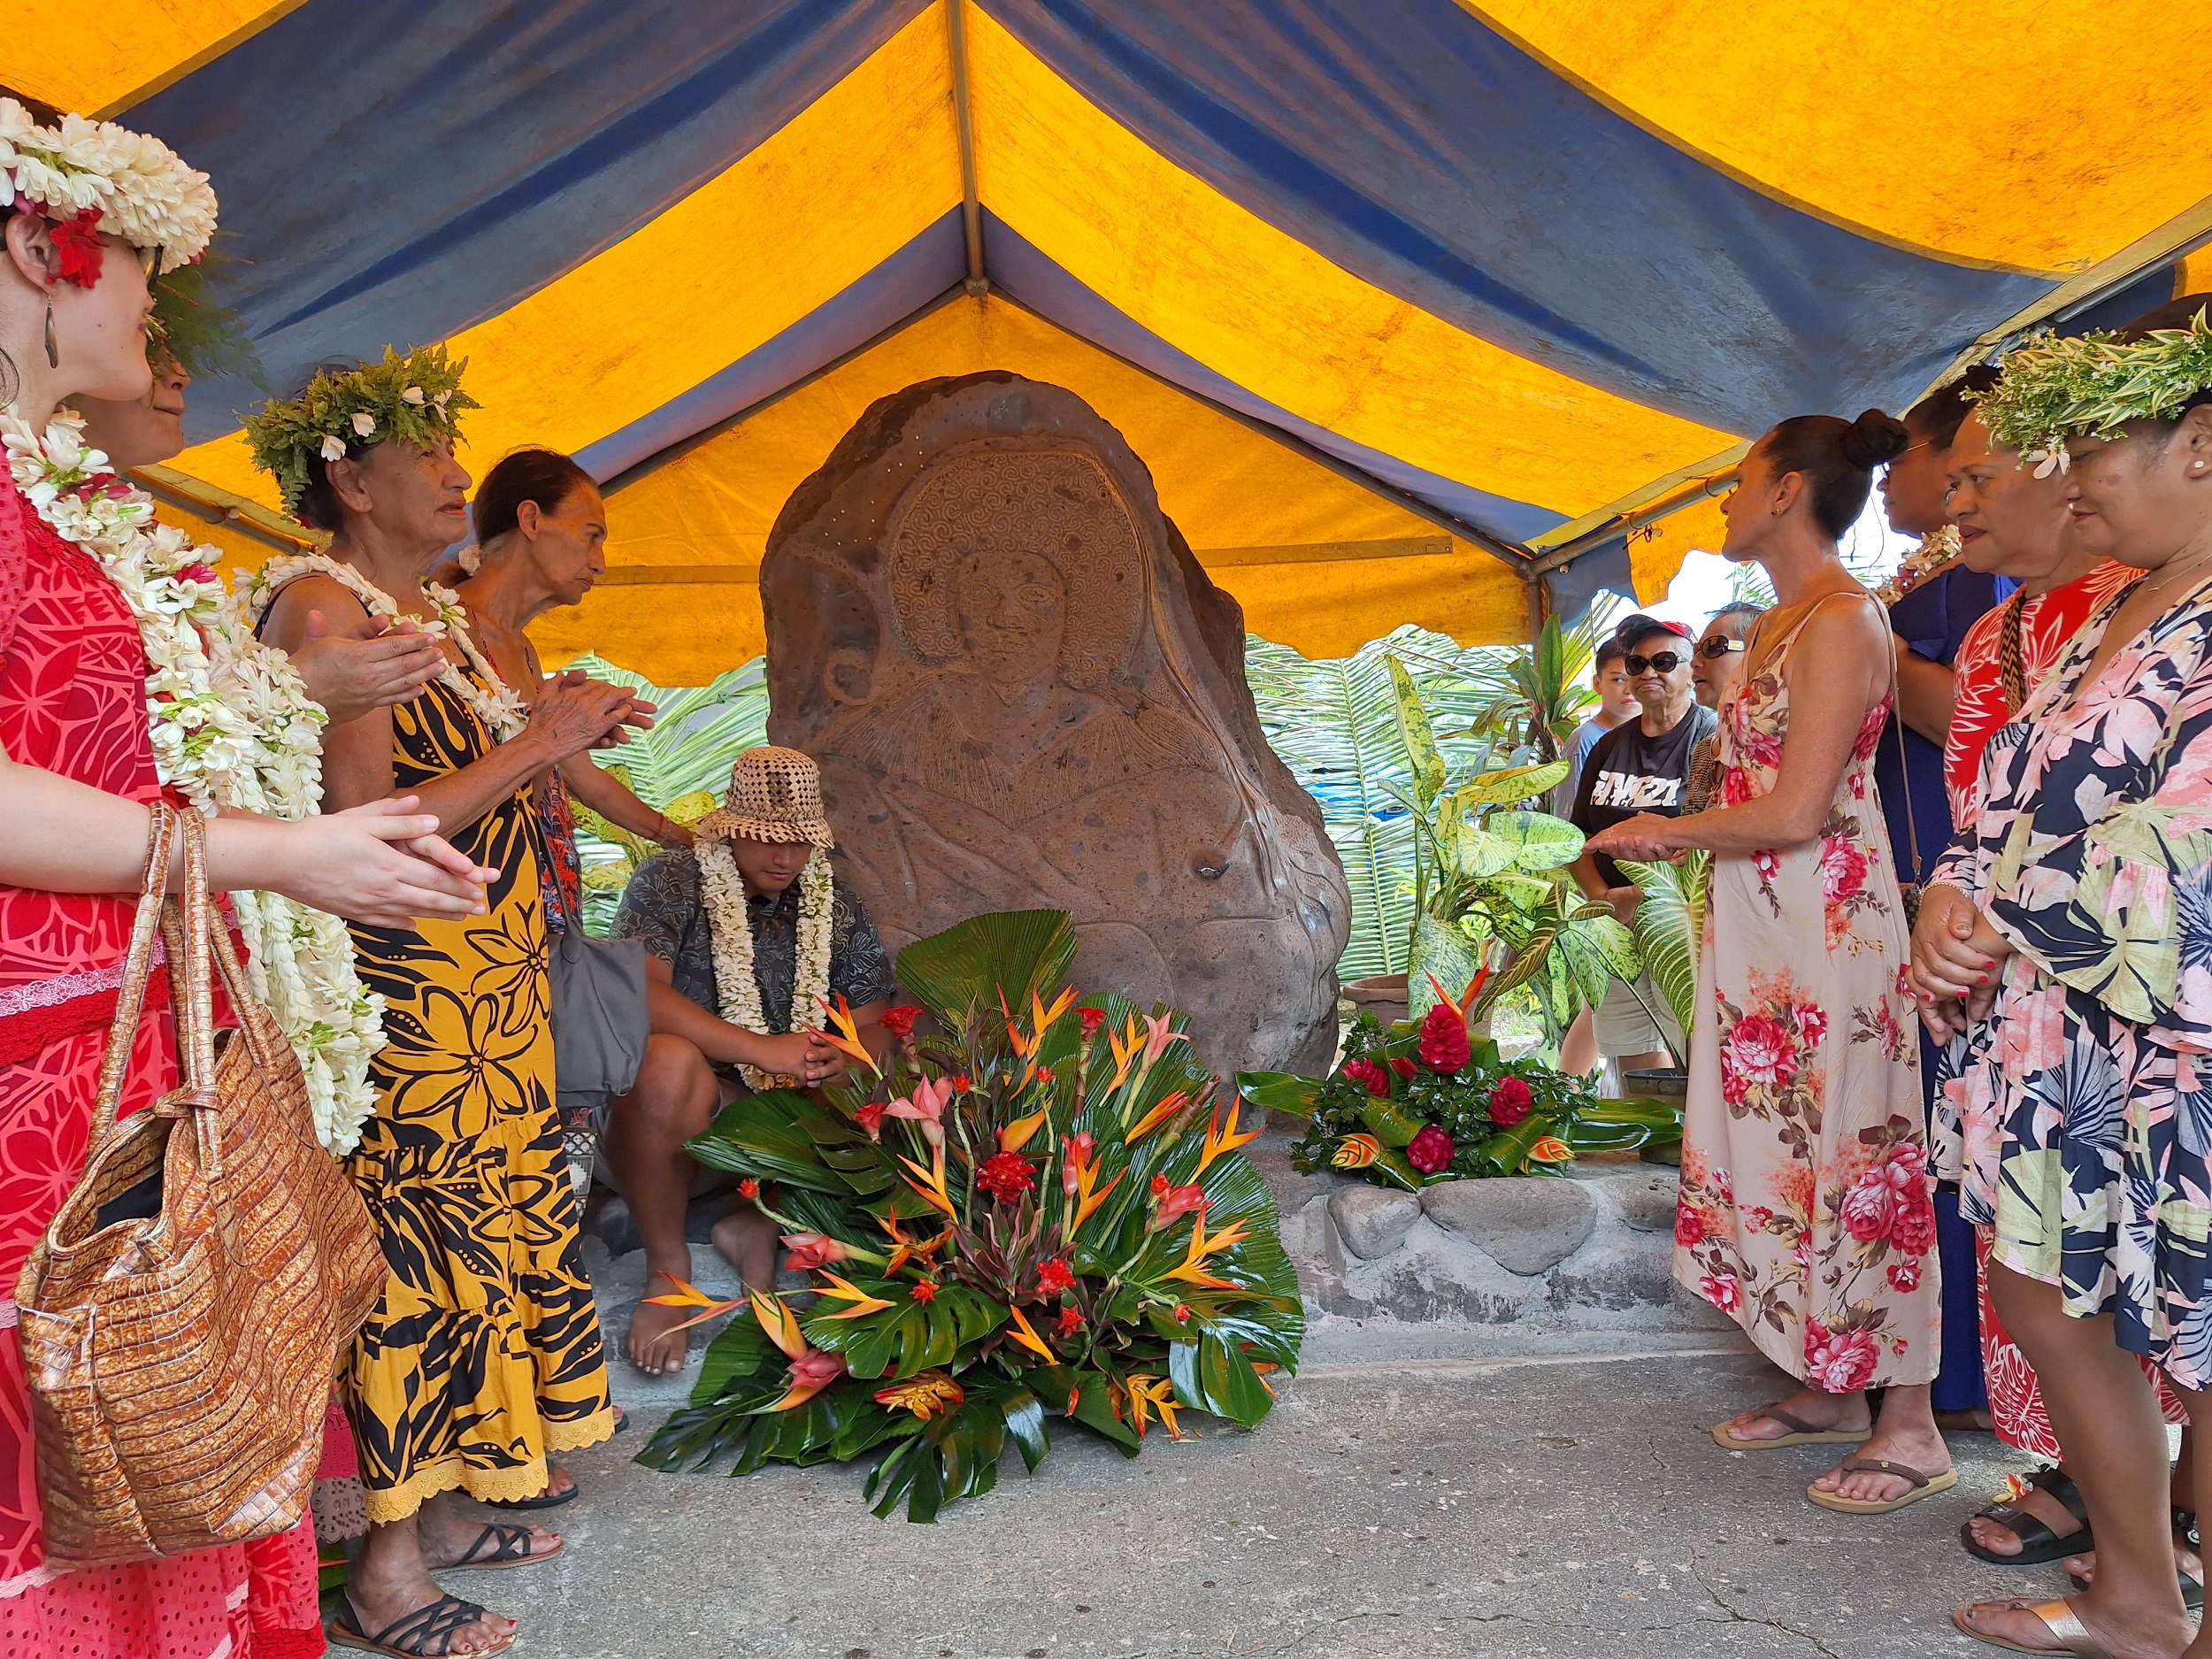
[1874,565,2017,1411]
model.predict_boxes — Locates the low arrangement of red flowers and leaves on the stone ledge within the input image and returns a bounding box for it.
[1237,995,1681,1193]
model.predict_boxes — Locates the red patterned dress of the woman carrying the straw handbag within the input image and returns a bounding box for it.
[0,485,323,1659]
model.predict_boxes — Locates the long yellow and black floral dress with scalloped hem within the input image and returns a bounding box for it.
[341,681,615,1522]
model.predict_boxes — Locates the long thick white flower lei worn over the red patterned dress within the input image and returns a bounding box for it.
[0,410,385,1153]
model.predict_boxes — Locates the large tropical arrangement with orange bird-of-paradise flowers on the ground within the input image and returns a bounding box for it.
[640,911,1305,1522]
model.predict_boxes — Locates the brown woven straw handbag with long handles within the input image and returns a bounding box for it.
[16,805,385,1566]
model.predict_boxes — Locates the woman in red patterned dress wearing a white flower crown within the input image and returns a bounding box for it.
[0,97,491,1659]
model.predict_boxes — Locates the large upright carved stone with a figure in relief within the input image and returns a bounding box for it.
[761,372,1352,1071]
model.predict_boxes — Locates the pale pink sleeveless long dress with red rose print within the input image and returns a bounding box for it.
[1675,602,1942,1394]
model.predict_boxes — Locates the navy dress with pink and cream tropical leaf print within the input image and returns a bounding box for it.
[1933,571,2212,1389]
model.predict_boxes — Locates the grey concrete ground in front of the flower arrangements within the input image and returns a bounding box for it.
[488,1345,2064,1659]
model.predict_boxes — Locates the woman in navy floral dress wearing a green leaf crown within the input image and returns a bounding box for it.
[1914,296,2212,1659]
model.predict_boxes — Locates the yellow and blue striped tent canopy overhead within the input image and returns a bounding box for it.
[0,0,2212,681]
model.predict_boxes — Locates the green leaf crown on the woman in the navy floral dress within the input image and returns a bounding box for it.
[1967,310,2212,472]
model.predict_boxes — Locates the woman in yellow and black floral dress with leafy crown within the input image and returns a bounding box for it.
[246,348,646,1655]
